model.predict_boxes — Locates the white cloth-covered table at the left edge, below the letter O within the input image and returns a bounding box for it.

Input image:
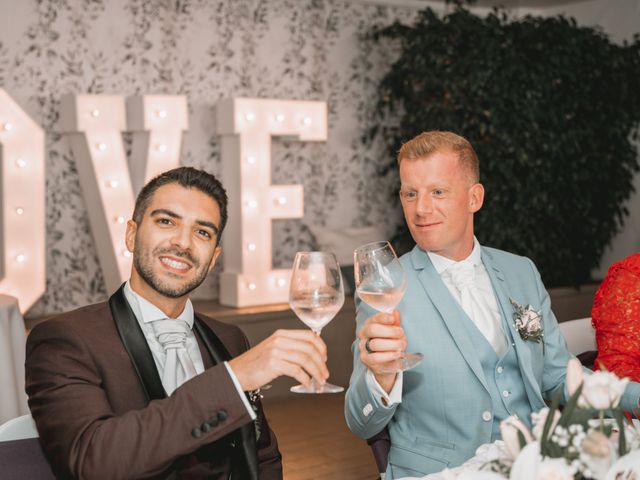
[0,295,29,424]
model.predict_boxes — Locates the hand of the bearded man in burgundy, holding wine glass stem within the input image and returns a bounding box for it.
[229,330,329,392]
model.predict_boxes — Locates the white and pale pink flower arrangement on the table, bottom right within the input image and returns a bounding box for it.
[484,358,640,480]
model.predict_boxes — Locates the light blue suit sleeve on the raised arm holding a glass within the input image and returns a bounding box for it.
[345,296,398,439]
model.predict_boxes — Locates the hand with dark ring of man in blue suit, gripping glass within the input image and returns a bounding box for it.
[358,310,407,393]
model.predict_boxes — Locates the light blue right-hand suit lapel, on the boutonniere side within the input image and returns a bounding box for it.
[482,248,544,405]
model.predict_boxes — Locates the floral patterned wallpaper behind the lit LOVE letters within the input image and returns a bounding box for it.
[0,0,417,317]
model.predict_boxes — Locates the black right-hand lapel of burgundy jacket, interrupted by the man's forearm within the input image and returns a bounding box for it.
[193,316,258,480]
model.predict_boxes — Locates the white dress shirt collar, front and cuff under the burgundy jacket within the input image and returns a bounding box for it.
[124,281,256,420]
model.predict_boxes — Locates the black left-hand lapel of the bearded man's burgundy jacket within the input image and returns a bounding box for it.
[109,284,167,401]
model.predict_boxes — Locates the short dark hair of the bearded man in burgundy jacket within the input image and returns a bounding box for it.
[133,167,227,238]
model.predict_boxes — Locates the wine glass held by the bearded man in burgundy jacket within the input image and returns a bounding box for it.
[289,252,344,393]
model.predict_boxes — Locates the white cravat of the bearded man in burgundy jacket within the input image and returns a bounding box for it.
[151,319,197,395]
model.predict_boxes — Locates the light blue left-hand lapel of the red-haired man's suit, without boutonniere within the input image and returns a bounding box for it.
[411,246,489,391]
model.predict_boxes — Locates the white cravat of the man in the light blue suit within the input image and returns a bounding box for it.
[443,259,507,357]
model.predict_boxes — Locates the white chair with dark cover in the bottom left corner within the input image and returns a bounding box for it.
[0,415,55,480]
